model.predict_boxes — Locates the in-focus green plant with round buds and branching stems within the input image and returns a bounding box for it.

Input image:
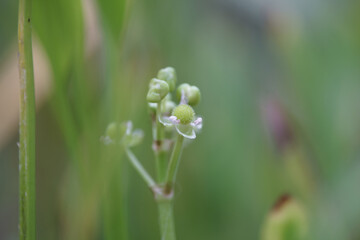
[102,67,202,240]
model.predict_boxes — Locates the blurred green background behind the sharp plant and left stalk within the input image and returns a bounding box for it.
[0,0,360,240]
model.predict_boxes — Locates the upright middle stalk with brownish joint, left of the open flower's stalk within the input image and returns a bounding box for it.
[154,102,167,183]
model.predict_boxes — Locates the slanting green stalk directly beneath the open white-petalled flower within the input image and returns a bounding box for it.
[165,134,184,194]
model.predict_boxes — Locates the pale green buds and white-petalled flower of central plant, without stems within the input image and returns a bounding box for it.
[101,67,202,147]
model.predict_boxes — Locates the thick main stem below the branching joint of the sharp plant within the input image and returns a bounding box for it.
[158,201,176,240]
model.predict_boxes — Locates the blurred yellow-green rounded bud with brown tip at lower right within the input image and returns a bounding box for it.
[261,195,308,240]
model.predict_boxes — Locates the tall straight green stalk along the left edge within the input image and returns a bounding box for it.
[18,0,36,240]
